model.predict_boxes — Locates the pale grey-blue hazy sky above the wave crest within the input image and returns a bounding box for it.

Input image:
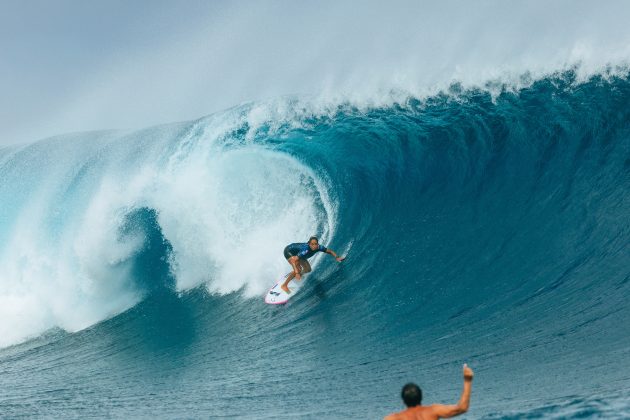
[0,0,630,146]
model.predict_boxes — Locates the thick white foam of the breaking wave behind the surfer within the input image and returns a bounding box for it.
[0,106,336,346]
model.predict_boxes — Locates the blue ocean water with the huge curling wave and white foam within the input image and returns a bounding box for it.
[0,71,630,419]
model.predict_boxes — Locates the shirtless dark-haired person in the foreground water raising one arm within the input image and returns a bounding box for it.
[385,364,473,420]
